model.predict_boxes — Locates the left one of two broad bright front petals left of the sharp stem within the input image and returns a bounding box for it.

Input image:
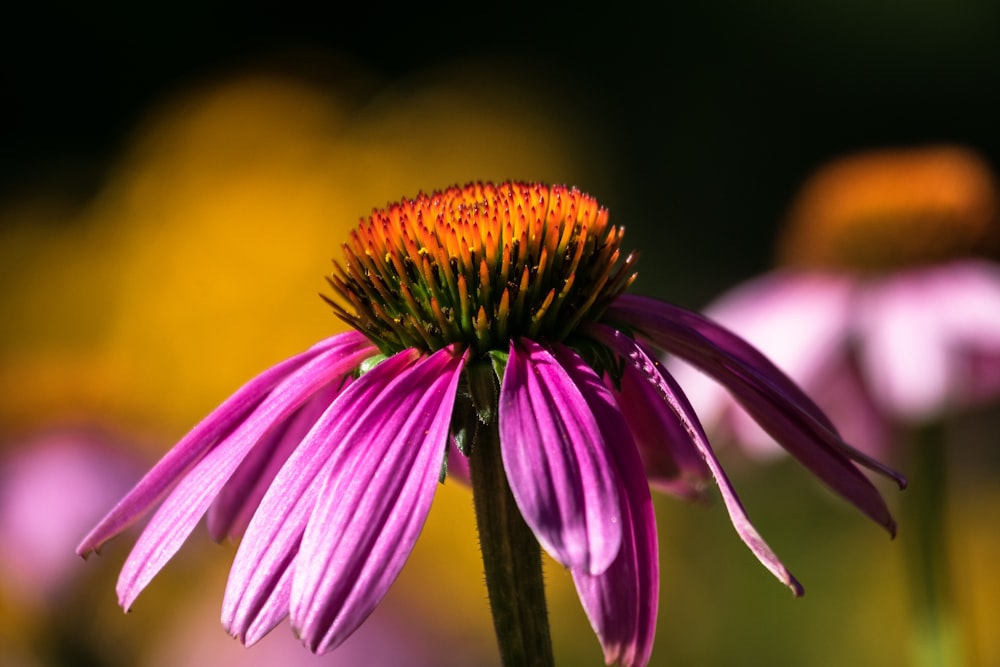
[222,350,419,646]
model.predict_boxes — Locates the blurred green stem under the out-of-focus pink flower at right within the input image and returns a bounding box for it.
[905,422,965,667]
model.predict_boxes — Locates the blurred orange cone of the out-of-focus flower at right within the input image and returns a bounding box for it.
[779,146,1000,272]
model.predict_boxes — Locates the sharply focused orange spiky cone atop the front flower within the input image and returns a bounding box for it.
[329,183,634,353]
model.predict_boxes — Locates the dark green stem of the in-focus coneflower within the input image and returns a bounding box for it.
[469,417,555,667]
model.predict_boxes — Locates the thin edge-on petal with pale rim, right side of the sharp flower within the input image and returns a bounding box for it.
[591,325,802,596]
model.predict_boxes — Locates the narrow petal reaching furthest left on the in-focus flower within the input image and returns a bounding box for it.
[76,331,373,556]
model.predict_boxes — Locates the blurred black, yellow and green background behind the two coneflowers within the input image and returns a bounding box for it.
[0,5,1000,667]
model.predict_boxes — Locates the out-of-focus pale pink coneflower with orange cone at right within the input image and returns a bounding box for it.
[671,146,1000,457]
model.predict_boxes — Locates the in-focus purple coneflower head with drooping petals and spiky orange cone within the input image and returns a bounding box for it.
[78,183,902,665]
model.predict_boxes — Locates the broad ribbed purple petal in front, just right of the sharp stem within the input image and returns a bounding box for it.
[499,339,621,574]
